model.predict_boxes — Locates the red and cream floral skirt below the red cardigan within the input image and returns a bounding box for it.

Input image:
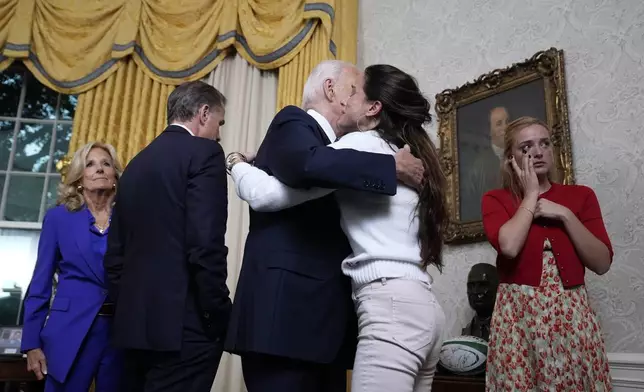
[486,240,612,392]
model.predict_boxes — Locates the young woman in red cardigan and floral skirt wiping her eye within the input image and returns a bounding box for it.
[482,117,613,391]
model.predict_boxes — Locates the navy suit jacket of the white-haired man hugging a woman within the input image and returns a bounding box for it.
[224,106,397,363]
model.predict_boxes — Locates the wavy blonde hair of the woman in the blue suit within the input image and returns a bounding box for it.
[56,142,123,211]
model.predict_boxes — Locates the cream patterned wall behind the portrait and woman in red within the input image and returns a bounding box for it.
[358,0,644,358]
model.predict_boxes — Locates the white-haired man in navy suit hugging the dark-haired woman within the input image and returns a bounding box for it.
[225,61,424,392]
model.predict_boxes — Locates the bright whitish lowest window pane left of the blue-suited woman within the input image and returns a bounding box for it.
[0,229,40,325]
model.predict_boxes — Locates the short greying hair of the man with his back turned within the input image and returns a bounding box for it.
[168,80,226,124]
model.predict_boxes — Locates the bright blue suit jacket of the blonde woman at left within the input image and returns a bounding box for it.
[21,206,107,382]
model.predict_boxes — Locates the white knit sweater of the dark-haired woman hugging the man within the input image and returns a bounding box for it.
[231,116,430,286]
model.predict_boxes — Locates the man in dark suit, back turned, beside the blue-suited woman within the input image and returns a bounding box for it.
[104,82,231,392]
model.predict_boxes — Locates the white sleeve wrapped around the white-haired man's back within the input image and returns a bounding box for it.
[230,162,334,212]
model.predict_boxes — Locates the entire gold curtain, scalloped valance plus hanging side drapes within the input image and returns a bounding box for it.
[0,0,358,167]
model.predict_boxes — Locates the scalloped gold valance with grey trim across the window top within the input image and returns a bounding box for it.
[0,0,340,93]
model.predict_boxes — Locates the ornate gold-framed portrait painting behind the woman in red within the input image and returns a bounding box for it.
[436,48,575,243]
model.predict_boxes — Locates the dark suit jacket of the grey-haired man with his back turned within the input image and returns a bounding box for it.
[104,126,230,351]
